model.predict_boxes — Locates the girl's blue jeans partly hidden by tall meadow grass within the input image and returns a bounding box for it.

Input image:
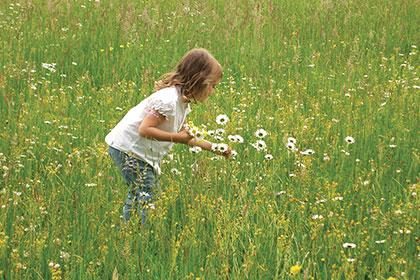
[109,147,156,224]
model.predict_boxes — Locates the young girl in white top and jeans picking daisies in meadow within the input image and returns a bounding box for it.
[105,49,231,223]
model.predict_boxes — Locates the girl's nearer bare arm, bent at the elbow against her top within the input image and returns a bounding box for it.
[138,112,193,144]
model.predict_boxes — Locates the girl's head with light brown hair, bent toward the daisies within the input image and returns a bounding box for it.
[156,49,222,102]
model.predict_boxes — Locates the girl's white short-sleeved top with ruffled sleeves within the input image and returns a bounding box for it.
[105,87,191,174]
